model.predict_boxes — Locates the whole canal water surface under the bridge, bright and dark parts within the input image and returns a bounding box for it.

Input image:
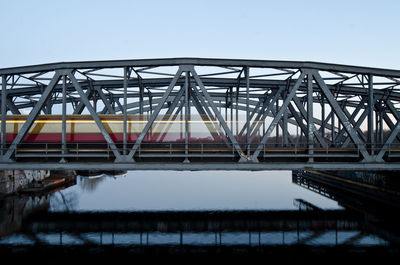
[0,171,400,260]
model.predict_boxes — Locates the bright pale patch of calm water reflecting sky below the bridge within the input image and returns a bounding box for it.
[50,171,341,211]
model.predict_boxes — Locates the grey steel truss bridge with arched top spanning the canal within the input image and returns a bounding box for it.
[0,58,400,170]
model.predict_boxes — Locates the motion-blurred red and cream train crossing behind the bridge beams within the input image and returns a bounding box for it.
[0,114,253,143]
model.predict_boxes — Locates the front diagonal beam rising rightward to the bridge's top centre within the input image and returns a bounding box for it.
[127,66,183,159]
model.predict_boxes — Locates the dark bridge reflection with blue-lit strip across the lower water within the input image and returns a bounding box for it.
[21,210,366,246]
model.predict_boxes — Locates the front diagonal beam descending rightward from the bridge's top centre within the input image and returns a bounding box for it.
[190,66,249,162]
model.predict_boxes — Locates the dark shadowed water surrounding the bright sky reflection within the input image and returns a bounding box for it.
[0,171,400,263]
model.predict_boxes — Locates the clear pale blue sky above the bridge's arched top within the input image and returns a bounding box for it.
[0,0,400,69]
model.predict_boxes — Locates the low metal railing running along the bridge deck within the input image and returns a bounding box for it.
[0,142,400,159]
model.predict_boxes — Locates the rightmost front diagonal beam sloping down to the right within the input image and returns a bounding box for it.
[312,70,372,162]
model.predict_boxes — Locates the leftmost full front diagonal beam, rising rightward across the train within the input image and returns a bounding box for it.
[1,71,61,161]
